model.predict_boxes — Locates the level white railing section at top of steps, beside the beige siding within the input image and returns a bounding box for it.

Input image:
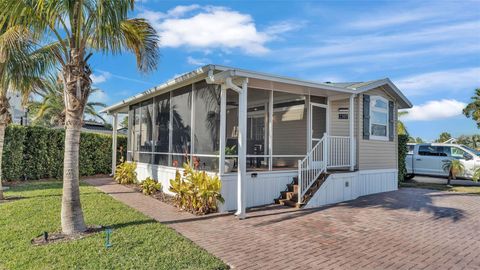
[327,135,352,168]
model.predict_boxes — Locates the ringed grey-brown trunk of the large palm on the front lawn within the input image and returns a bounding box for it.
[61,116,86,234]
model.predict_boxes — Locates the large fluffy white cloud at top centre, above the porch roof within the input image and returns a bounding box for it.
[140,5,296,55]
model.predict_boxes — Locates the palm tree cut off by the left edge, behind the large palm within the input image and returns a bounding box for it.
[0,25,52,200]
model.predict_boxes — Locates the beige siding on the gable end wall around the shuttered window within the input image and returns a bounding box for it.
[357,88,397,170]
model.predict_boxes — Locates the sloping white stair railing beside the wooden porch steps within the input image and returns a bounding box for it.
[297,133,328,204]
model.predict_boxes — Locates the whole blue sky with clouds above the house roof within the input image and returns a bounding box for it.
[91,0,480,140]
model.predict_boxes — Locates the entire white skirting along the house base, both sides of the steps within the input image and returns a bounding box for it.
[137,163,398,212]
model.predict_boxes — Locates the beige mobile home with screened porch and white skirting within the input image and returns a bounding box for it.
[103,65,412,217]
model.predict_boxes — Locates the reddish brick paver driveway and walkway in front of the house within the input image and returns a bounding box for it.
[88,179,480,269]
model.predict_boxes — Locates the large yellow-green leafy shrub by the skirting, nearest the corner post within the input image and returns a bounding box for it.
[169,163,224,214]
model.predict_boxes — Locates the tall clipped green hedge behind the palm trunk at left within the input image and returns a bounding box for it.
[2,125,127,181]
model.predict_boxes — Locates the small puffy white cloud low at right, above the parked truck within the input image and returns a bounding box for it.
[401,99,466,121]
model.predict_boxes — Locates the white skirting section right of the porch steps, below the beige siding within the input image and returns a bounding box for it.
[305,169,398,208]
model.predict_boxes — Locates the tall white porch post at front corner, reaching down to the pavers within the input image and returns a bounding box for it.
[235,79,248,219]
